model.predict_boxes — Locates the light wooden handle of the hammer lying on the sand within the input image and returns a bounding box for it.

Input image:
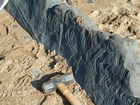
[57,83,82,105]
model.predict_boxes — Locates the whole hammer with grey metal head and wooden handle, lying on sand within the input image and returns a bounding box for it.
[42,74,81,105]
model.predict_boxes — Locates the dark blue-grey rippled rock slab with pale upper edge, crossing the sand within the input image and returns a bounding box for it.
[6,0,140,105]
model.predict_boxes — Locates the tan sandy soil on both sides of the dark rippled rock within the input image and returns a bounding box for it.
[0,0,140,105]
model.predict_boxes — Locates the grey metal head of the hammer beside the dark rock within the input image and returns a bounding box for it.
[42,74,74,93]
